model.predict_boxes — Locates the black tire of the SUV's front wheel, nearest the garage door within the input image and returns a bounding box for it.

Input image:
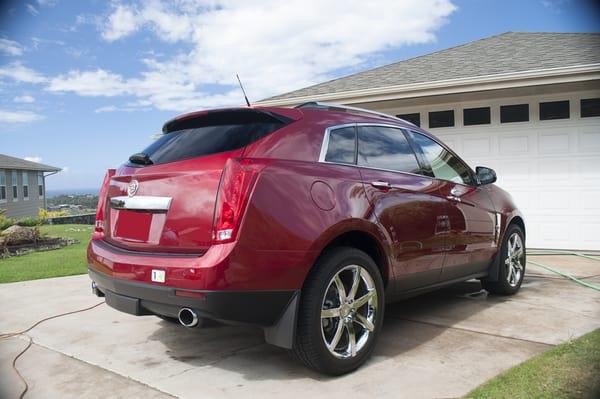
[481,224,527,295]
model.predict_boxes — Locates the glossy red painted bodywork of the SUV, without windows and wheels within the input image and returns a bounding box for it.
[88,108,521,300]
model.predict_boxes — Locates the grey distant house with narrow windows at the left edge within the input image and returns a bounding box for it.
[0,154,61,218]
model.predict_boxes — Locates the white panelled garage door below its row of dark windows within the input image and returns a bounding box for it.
[436,113,600,250]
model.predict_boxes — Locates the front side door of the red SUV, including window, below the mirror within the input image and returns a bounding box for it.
[410,131,497,281]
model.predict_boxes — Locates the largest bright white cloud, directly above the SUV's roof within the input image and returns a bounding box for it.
[48,0,456,111]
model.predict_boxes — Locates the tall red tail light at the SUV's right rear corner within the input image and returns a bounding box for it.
[212,159,265,244]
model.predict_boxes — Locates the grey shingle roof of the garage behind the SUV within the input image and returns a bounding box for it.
[263,32,600,101]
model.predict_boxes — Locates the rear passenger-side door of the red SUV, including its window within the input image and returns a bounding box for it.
[357,124,447,292]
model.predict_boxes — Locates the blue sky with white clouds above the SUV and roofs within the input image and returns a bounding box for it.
[0,0,600,189]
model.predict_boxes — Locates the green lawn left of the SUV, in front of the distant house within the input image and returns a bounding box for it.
[0,224,93,283]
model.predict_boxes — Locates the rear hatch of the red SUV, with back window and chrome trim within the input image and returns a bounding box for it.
[104,109,292,253]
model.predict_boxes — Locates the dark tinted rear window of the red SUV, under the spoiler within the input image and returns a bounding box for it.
[129,110,291,166]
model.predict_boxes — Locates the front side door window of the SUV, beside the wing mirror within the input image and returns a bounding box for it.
[412,132,473,184]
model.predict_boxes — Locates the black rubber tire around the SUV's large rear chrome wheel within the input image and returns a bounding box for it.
[293,247,385,375]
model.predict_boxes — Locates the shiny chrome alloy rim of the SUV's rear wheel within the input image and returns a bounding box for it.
[321,265,377,359]
